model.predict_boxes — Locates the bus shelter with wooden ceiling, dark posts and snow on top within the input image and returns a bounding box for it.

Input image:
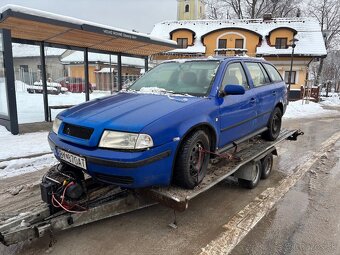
[0,5,177,134]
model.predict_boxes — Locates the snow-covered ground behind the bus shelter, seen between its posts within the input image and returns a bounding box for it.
[16,91,110,124]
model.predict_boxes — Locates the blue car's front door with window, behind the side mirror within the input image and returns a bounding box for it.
[219,62,256,148]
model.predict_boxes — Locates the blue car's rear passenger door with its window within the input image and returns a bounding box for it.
[245,62,276,129]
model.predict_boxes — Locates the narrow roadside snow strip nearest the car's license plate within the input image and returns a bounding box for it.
[0,154,58,180]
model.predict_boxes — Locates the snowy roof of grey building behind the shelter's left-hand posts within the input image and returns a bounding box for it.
[12,43,65,58]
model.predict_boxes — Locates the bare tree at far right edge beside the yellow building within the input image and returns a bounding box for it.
[307,0,340,85]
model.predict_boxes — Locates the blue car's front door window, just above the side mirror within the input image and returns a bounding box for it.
[221,63,249,90]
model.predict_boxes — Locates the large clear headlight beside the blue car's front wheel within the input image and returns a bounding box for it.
[99,130,153,150]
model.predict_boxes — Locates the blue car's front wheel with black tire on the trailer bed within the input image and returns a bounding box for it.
[174,130,210,189]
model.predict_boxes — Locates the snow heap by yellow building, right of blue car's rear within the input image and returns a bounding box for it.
[283,100,339,119]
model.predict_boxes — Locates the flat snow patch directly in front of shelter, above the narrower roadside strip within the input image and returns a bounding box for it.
[0,126,51,160]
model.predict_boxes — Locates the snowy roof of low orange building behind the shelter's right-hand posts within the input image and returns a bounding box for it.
[61,51,145,67]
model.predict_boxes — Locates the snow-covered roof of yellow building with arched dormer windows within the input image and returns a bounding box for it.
[151,18,327,56]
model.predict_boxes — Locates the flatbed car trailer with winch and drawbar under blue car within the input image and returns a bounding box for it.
[0,130,303,246]
